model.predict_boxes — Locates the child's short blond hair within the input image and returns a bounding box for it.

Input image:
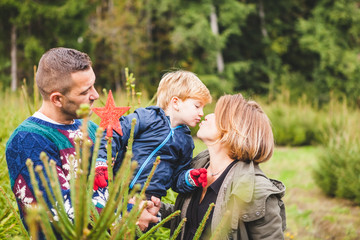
[157,70,212,109]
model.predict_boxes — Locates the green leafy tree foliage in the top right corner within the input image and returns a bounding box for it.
[297,1,360,105]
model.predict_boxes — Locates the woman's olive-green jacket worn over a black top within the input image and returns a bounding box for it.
[160,150,286,240]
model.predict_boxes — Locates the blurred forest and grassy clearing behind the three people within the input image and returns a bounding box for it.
[0,0,360,239]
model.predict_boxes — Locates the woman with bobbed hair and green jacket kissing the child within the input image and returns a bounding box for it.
[159,94,286,240]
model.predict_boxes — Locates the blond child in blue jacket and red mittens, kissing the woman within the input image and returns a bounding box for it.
[98,70,211,199]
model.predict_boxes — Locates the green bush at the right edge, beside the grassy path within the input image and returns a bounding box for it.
[314,97,360,204]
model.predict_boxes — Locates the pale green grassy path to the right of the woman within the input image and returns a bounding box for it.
[262,147,360,240]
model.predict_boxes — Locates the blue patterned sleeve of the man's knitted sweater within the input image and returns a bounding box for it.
[6,132,73,222]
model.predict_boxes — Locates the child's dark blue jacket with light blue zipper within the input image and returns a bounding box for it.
[98,106,194,198]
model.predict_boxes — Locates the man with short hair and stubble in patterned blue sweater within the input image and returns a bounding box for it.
[6,48,157,235]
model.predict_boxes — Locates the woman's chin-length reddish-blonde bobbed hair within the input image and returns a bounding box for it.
[215,94,274,163]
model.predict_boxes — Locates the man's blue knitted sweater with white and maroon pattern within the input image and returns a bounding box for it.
[6,117,105,231]
